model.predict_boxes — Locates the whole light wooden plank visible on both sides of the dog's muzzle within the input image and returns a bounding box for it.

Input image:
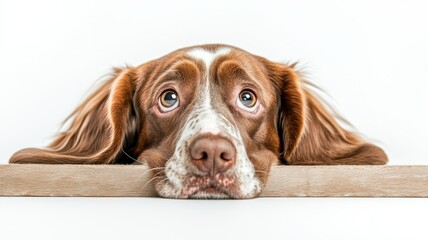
[0,164,428,197]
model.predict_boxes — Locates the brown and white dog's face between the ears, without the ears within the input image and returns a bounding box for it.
[135,46,280,198]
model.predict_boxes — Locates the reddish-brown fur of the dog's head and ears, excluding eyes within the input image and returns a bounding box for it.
[10,45,387,188]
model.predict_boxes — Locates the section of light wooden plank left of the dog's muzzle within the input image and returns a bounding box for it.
[0,164,156,197]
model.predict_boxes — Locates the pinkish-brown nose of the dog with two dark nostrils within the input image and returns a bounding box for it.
[189,135,236,176]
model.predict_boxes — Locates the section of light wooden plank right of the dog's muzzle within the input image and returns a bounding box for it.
[262,165,428,197]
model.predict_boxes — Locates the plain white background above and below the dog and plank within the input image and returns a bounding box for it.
[0,0,428,239]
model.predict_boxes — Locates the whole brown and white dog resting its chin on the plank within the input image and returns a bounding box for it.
[10,45,388,198]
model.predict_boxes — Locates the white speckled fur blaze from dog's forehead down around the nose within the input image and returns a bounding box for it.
[158,48,260,198]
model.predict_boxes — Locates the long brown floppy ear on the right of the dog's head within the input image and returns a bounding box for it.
[268,62,388,165]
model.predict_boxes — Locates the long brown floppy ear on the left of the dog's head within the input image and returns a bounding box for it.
[10,68,137,164]
